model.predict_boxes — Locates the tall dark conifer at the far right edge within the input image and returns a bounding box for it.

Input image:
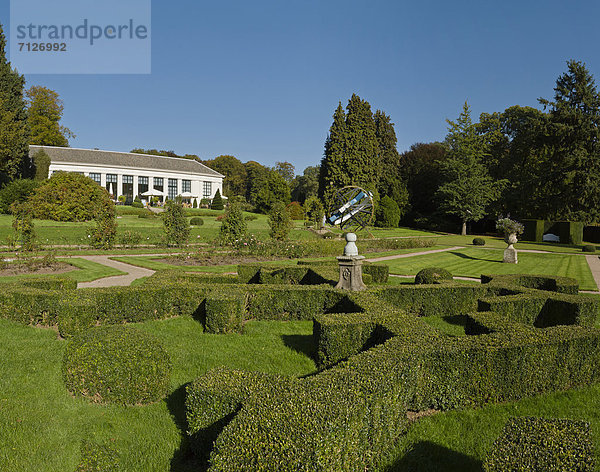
[539,60,600,222]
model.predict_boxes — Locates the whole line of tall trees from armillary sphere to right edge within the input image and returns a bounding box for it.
[318,60,600,233]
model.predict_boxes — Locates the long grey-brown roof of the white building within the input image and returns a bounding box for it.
[29,146,224,177]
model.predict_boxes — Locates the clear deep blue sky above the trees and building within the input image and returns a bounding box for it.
[0,0,600,173]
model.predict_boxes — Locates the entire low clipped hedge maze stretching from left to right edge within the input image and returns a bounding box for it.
[0,267,600,471]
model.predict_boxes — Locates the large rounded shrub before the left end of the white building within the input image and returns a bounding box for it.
[30,172,114,221]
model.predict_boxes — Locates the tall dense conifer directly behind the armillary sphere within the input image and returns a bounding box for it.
[319,94,380,203]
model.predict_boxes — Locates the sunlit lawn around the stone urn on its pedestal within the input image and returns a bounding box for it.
[381,248,598,290]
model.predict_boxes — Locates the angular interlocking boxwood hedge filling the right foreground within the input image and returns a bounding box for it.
[187,277,600,471]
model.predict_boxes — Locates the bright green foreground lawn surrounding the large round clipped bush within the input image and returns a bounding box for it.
[0,318,315,472]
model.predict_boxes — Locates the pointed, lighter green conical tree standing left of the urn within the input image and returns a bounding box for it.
[437,102,504,235]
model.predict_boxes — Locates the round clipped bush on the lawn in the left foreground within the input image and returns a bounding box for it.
[63,325,171,405]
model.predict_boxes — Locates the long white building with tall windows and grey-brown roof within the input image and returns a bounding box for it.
[29,146,223,202]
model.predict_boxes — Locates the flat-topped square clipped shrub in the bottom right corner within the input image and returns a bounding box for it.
[483,417,595,472]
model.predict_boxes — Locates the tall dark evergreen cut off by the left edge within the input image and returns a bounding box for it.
[0,25,32,180]
